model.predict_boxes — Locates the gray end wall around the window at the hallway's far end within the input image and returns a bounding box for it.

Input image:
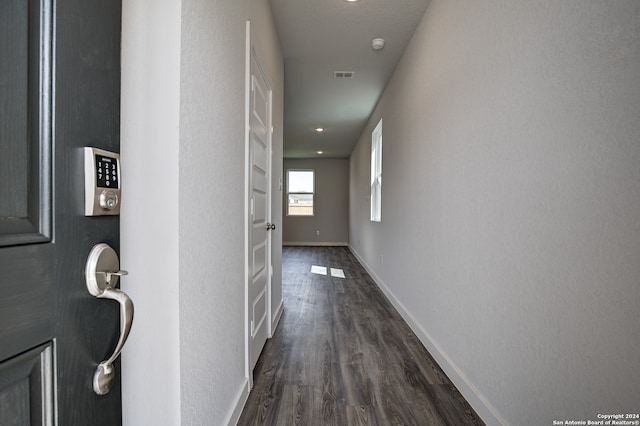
[282,159,349,245]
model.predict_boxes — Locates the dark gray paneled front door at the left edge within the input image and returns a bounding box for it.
[0,0,122,426]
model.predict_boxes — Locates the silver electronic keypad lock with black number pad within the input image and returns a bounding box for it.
[84,147,120,216]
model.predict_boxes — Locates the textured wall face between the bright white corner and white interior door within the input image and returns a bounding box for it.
[178,0,249,424]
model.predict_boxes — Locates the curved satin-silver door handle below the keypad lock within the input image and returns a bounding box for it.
[85,243,133,395]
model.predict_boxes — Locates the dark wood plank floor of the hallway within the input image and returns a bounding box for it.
[238,247,484,425]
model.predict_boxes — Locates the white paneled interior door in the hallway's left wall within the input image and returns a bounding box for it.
[247,31,272,371]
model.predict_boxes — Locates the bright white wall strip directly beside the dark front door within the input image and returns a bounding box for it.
[120,0,181,426]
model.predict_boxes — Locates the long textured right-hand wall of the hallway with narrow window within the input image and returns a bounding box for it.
[350,0,640,425]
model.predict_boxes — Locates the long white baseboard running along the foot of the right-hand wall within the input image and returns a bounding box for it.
[349,246,508,425]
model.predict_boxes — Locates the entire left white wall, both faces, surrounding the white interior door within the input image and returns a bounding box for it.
[121,0,283,425]
